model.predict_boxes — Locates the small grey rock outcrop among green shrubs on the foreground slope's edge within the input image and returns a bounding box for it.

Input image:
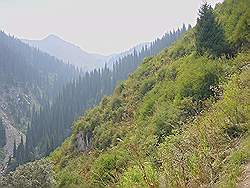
[75,131,93,152]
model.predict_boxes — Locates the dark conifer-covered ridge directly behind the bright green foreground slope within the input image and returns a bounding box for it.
[18,25,190,167]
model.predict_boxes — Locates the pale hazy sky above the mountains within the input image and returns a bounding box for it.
[0,0,222,55]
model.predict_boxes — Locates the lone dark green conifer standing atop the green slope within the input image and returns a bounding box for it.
[195,3,229,57]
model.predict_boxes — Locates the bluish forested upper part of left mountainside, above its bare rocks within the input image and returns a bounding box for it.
[0,32,77,98]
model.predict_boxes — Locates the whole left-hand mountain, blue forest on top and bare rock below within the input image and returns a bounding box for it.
[0,31,80,163]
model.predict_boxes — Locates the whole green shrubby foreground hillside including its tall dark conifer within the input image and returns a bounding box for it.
[0,0,250,188]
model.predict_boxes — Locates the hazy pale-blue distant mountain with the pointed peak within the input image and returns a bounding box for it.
[22,35,108,71]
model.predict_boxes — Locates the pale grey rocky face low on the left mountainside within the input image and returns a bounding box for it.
[0,85,31,164]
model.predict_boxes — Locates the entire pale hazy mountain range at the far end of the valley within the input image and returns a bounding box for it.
[22,35,151,71]
